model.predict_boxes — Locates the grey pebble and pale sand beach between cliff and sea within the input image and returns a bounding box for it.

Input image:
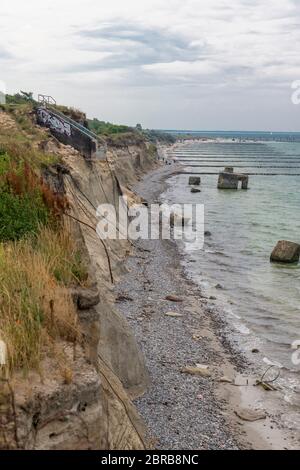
[117,165,299,450]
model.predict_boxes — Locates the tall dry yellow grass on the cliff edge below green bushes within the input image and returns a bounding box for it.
[0,227,87,373]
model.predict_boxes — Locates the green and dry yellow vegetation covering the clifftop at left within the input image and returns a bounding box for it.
[0,105,88,374]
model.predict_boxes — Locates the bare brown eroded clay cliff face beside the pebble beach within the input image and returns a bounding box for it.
[0,130,155,449]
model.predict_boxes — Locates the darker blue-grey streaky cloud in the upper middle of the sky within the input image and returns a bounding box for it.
[65,21,208,73]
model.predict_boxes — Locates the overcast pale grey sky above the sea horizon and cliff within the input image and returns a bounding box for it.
[0,0,300,131]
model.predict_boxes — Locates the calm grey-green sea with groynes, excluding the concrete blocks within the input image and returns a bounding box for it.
[165,142,300,371]
